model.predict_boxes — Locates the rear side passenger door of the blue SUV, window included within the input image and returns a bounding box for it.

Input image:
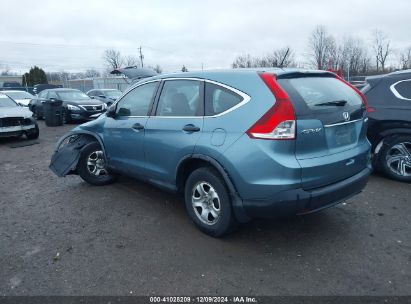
[144,79,204,186]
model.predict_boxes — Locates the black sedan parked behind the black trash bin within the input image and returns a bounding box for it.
[29,89,107,122]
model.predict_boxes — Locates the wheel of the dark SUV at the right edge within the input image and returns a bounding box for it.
[378,135,411,182]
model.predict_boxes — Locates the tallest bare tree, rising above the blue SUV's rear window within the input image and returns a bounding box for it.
[308,25,336,70]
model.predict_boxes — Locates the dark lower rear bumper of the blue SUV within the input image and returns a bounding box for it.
[240,168,371,218]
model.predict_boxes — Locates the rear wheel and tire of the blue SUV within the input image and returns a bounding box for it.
[184,167,238,237]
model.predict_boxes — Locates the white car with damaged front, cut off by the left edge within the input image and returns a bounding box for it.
[0,92,39,139]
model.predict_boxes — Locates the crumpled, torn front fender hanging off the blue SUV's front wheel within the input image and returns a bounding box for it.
[49,133,101,177]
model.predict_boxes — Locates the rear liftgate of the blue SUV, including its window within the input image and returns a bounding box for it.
[278,74,369,189]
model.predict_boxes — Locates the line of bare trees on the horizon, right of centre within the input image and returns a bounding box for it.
[232,25,411,75]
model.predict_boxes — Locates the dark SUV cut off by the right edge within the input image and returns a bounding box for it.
[362,70,411,182]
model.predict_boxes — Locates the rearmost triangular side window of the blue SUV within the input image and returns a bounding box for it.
[205,83,243,116]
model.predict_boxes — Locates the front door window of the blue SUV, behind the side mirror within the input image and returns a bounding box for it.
[116,82,158,116]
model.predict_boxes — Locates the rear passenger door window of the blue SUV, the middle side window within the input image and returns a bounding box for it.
[156,80,203,116]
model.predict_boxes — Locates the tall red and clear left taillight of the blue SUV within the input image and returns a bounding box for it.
[247,73,296,139]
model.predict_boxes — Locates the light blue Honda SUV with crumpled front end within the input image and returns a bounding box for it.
[50,69,371,236]
